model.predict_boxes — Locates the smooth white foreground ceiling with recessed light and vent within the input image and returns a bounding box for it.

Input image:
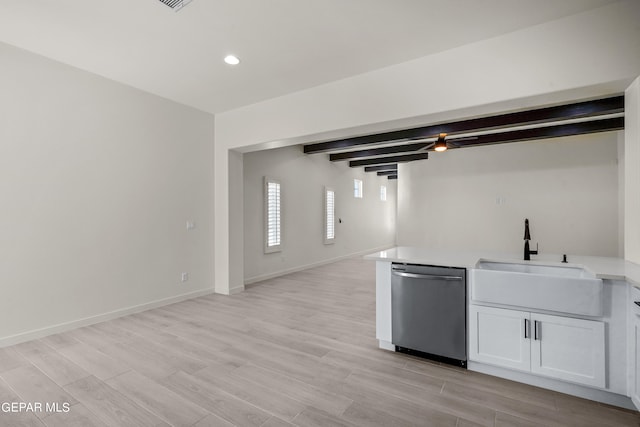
[0,0,617,113]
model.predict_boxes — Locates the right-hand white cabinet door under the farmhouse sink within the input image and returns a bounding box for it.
[531,313,605,387]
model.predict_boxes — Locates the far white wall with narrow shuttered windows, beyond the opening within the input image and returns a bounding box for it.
[244,146,396,283]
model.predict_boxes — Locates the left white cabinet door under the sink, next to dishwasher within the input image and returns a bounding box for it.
[469,305,531,371]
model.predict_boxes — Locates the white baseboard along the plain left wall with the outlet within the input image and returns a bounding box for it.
[0,289,214,348]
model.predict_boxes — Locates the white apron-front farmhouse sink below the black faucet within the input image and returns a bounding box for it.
[469,259,603,316]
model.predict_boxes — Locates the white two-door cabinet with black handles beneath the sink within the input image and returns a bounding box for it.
[469,305,605,387]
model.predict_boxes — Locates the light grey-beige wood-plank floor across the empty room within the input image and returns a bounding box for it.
[0,259,640,427]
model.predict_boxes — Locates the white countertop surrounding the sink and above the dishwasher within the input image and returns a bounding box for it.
[365,246,640,287]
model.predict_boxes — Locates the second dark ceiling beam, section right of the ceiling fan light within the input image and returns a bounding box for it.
[450,117,624,148]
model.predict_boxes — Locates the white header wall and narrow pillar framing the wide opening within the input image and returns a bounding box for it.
[215,0,640,293]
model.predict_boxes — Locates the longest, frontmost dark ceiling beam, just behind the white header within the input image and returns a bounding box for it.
[304,95,624,154]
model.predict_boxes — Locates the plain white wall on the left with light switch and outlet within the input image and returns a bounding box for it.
[0,44,214,345]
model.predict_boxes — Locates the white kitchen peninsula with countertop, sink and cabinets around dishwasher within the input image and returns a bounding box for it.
[365,247,640,408]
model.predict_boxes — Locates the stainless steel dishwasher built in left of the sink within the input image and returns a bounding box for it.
[391,263,467,367]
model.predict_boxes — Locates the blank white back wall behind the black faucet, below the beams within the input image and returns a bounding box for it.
[397,132,621,256]
